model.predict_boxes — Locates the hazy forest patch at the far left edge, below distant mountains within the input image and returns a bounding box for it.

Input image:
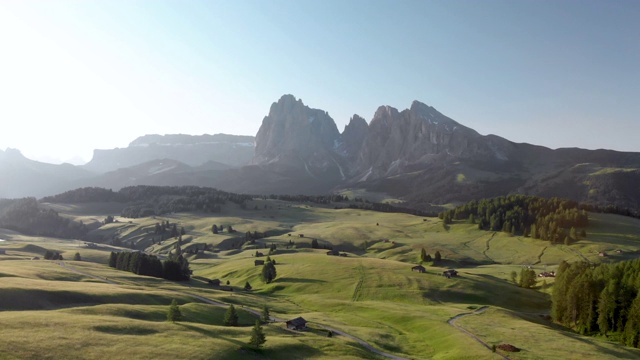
[0,198,88,239]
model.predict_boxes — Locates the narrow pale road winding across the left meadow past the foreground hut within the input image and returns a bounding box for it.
[57,261,410,360]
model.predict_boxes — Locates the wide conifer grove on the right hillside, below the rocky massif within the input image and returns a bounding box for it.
[438,195,589,242]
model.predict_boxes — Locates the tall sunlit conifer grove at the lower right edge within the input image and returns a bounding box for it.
[551,260,640,347]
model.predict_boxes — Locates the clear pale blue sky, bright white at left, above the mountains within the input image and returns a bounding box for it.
[0,0,640,164]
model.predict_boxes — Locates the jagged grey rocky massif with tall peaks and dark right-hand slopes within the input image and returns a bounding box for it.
[244,95,640,211]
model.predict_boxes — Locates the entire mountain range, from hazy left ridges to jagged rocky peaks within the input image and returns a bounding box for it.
[0,95,640,209]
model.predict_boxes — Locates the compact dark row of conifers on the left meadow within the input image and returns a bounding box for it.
[109,251,191,281]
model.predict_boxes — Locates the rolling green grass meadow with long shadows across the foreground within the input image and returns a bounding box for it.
[0,200,640,359]
